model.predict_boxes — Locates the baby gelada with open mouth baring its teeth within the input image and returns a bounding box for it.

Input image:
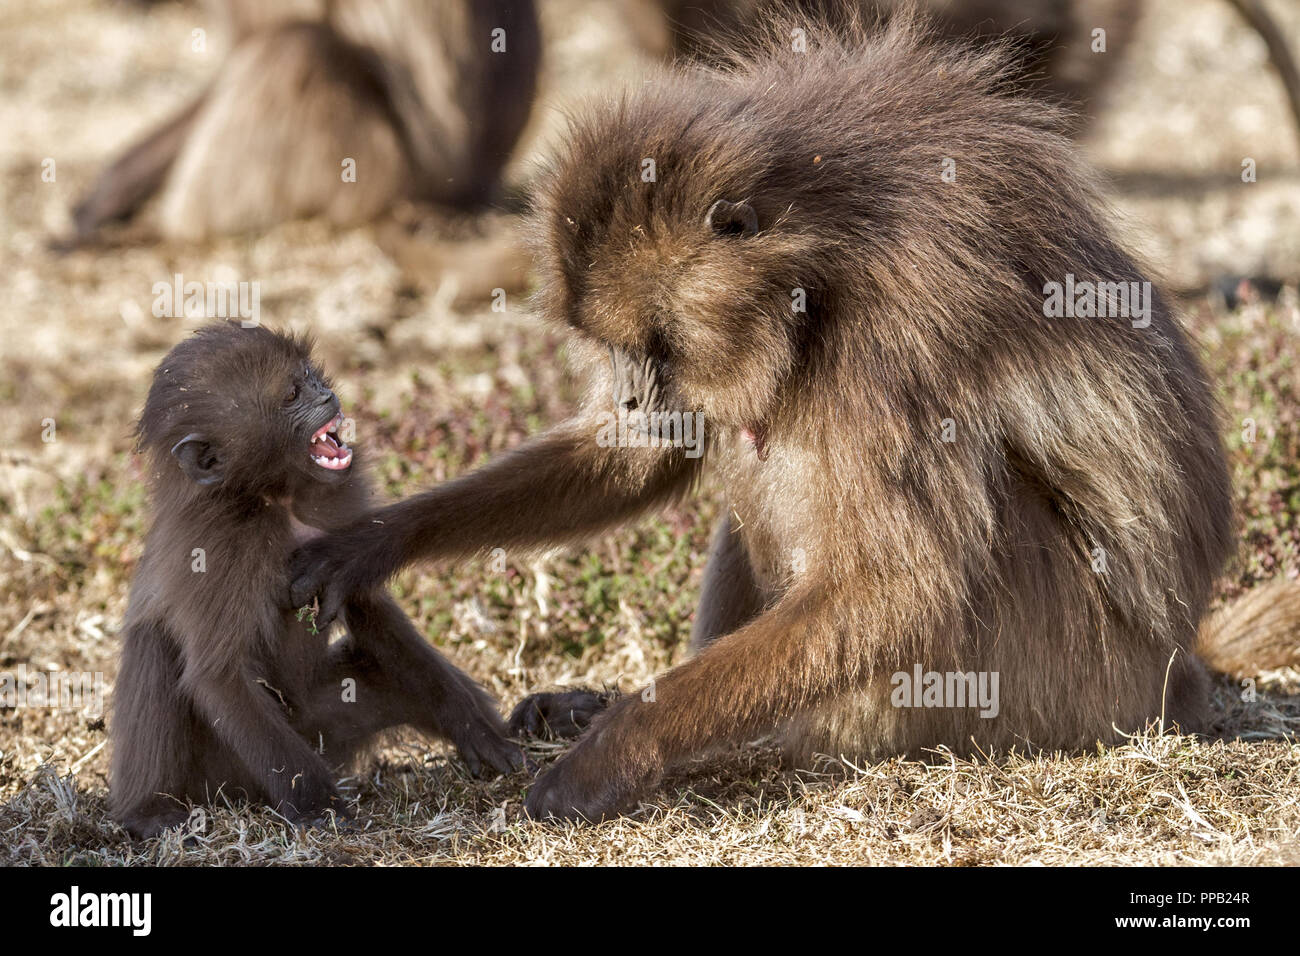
[109,323,523,836]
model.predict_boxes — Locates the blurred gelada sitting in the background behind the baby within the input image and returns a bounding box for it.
[74,0,541,239]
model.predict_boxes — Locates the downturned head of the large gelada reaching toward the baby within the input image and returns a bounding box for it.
[540,89,815,428]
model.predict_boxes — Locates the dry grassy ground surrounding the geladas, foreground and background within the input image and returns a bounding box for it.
[0,0,1300,865]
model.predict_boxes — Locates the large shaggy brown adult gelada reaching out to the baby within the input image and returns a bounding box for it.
[291,17,1300,818]
